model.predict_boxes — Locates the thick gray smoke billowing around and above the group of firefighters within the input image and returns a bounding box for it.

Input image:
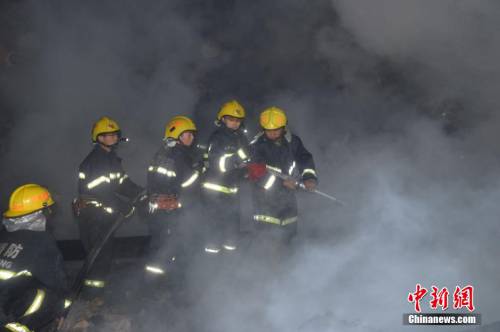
[2,0,500,331]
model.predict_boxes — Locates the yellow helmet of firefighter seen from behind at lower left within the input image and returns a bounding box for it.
[3,183,54,218]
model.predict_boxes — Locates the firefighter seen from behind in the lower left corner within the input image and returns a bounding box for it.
[0,184,68,331]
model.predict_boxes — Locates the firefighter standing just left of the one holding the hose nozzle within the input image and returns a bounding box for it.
[203,100,249,254]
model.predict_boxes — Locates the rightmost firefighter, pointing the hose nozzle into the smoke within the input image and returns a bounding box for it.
[248,107,317,244]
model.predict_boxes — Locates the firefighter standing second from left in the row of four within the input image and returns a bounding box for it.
[145,116,204,275]
